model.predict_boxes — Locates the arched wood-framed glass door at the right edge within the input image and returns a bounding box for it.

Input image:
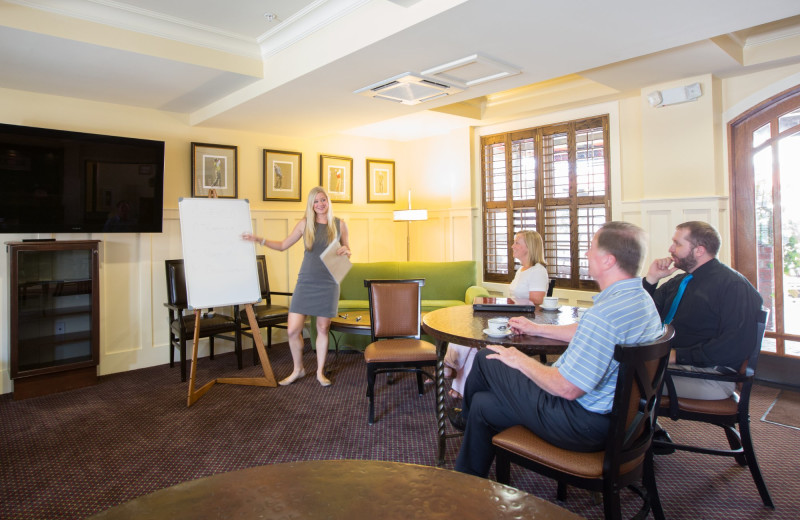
[731,86,800,358]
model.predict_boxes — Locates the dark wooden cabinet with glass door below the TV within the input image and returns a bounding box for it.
[6,240,100,399]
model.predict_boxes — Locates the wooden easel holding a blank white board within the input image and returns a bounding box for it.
[178,196,278,406]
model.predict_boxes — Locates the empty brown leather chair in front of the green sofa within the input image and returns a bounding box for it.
[364,279,436,424]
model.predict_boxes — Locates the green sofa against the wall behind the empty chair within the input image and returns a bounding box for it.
[310,260,489,350]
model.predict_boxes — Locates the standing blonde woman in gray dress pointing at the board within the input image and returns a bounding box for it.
[242,186,350,386]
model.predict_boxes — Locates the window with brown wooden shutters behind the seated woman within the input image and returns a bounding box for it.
[481,115,611,290]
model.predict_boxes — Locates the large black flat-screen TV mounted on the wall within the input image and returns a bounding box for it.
[0,124,164,233]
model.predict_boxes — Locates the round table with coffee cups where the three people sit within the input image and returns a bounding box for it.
[422,305,579,464]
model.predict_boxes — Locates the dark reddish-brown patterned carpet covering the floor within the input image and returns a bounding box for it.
[0,345,800,520]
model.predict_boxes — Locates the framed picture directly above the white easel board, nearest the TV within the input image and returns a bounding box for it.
[192,143,238,199]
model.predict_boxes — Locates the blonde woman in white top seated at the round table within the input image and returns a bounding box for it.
[444,231,549,399]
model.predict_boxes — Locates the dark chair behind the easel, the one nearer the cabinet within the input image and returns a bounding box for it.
[164,259,242,381]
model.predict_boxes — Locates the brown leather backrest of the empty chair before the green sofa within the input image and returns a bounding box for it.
[364,278,425,341]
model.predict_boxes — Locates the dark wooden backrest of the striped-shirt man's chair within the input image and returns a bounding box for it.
[603,325,675,475]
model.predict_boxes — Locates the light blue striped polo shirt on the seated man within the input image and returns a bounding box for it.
[553,278,663,413]
